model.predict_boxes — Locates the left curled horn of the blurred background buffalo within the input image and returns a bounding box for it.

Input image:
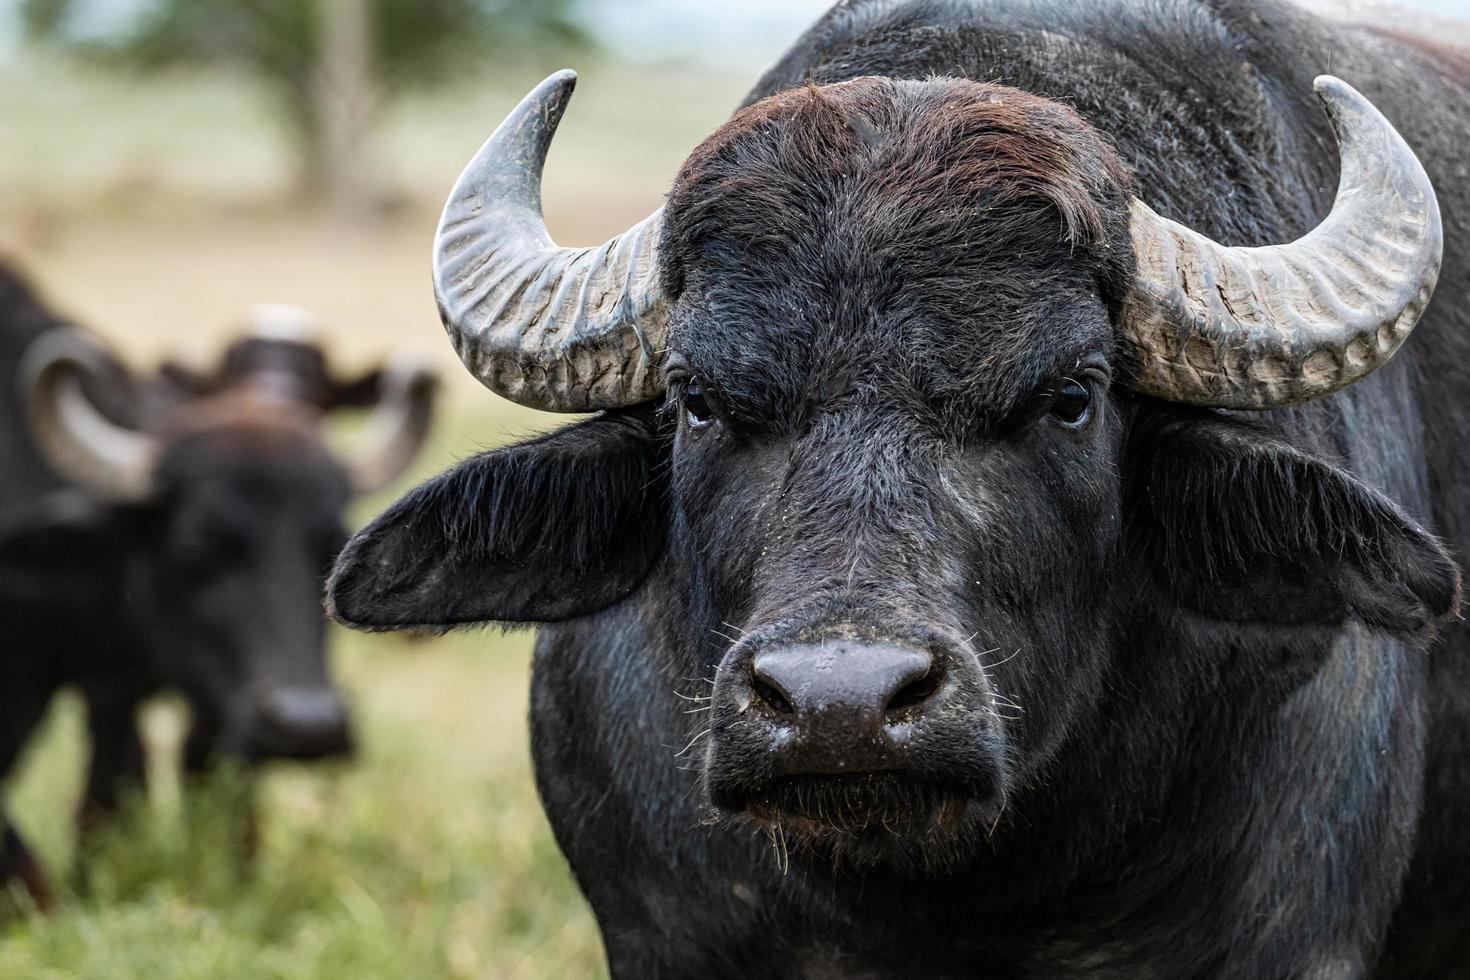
[19,328,159,501]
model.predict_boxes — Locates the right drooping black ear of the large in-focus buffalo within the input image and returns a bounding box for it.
[1130,419,1460,638]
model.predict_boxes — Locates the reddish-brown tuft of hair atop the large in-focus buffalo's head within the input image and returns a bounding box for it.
[669,78,1130,301]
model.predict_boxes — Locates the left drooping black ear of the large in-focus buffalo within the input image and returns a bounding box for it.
[326,407,667,630]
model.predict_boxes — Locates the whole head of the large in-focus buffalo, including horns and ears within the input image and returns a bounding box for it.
[329,75,1458,862]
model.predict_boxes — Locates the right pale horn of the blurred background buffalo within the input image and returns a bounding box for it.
[347,356,438,494]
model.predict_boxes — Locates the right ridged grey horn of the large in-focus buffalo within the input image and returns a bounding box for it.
[1123,75,1444,410]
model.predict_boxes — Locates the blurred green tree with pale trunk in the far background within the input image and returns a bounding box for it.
[21,0,589,215]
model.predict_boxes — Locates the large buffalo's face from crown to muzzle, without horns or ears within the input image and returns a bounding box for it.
[663,76,1130,860]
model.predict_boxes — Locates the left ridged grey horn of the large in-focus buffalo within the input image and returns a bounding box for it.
[434,71,667,411]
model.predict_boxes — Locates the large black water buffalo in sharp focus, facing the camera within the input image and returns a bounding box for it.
[329,0,1470,980]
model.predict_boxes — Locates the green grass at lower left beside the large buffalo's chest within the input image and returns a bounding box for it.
[0,411,603,980]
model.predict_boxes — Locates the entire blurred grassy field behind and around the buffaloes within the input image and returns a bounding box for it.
[0,51,747,980]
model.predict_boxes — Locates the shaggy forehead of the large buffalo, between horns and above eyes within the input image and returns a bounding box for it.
[669,79,1127,431]
